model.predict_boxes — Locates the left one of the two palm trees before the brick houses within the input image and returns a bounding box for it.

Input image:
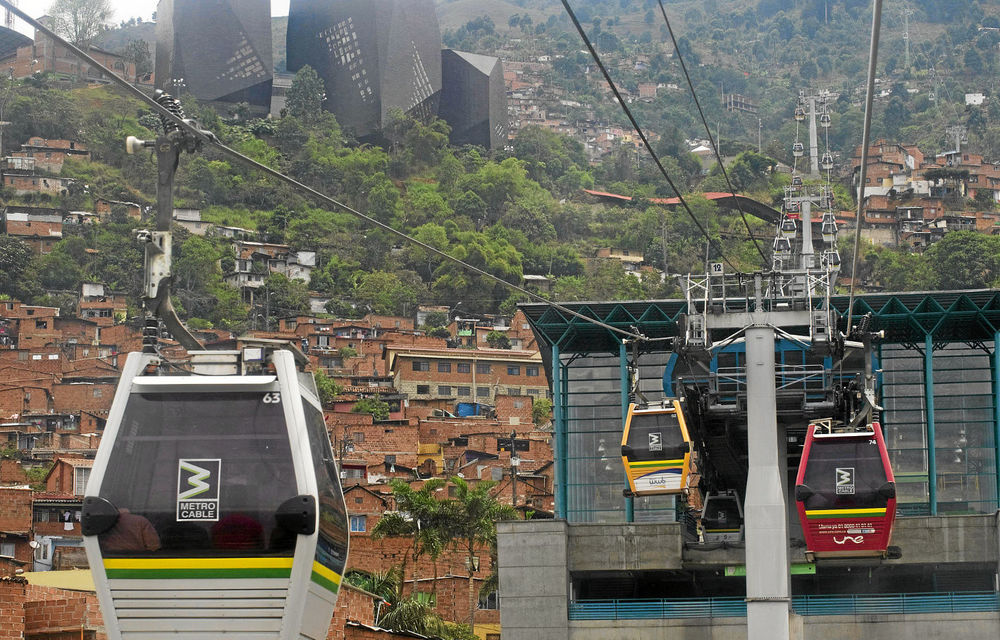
[372,478,447,599]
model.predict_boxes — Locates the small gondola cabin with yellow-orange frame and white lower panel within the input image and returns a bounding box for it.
[622,400,691,496]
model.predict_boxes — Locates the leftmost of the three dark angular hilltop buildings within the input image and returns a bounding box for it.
[156,0,274,109]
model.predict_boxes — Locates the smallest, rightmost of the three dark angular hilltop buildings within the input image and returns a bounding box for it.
[439,49,508,149]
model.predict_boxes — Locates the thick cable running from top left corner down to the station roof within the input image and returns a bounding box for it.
[0,0,648,340]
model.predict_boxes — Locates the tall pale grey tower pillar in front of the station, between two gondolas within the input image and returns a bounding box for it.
[744,325,791,640]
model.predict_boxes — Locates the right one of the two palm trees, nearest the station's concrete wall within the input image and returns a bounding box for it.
[446,476,517,631]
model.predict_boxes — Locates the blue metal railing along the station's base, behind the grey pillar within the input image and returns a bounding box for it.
[569,591,1000,620]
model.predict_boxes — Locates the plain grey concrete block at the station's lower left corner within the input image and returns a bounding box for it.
[497,520,571,640]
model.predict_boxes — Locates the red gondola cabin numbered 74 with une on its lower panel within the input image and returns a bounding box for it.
[795,421,896,560]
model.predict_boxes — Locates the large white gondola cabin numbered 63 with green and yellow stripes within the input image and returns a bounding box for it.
[82,348,348,640]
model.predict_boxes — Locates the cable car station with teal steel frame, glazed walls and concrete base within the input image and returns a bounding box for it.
[498,290,1000,640]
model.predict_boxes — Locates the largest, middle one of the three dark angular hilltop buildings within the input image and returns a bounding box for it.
[287,0,441,138]
